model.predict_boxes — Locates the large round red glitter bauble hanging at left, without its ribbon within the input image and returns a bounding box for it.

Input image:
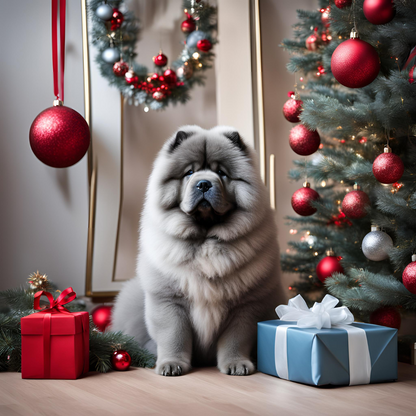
[29,102,90,168]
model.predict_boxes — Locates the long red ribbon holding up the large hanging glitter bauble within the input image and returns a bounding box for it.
[52,0,66,102]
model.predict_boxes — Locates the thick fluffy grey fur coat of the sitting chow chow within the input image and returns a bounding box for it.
[113,126,281,376]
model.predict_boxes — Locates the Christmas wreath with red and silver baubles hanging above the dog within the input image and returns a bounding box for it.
[89,0,217,111]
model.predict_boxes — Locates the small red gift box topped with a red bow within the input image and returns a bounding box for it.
[20,287,90,379]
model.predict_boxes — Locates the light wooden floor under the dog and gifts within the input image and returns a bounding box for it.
[0,363,416,416]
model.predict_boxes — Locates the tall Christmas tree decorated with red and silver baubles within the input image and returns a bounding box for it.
[282,0,416,327]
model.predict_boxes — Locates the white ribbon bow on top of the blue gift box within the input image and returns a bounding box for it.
[276,295,354,329]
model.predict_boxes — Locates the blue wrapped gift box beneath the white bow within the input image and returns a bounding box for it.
[257,320,397,386]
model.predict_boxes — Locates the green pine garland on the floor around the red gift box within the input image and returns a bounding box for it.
[0,281,156,373]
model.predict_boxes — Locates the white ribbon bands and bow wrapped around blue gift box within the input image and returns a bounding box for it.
[275,295,371,386]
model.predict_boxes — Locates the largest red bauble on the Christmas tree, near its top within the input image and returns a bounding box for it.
[331,29,380,88]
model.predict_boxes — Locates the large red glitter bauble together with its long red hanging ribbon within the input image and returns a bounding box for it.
[29,0,90,168]
